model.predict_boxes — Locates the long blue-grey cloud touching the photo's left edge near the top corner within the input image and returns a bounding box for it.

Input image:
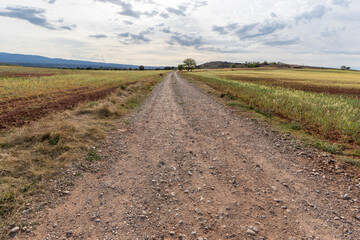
[0,7,76,30]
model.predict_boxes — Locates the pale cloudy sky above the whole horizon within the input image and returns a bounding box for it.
[0,0,360,69]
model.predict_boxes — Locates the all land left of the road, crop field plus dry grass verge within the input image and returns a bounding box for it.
[0,66,167,229]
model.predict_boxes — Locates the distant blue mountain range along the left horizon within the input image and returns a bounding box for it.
[0,52,164,69]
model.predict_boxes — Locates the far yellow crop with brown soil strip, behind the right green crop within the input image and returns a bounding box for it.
[193,68,360,96]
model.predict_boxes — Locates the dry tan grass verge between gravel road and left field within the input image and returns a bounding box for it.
[0,75,163,233]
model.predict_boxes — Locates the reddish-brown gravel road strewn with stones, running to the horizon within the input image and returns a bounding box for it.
[15,73,360,240]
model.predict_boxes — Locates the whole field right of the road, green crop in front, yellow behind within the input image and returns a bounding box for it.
[186,69,360,146]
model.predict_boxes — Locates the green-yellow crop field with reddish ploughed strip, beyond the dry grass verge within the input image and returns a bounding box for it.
[0,66,167,128]
